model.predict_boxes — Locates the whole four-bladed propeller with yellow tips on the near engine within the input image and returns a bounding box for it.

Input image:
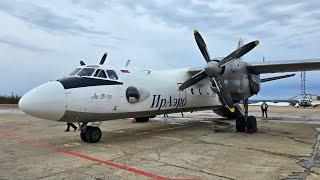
[179,30,259,112]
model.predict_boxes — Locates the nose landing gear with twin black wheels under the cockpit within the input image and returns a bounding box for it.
[80,122,102,143]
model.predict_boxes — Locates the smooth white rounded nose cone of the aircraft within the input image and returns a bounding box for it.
[19,81,65,120]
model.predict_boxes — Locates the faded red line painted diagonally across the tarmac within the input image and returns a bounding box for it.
[0,125,195,180]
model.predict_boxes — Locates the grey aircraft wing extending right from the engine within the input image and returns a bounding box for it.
[247,59,320,74]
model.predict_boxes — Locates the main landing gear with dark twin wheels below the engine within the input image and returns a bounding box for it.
[236,99,258,134]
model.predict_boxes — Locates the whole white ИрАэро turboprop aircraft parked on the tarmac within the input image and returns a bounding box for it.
[19,30,320,143]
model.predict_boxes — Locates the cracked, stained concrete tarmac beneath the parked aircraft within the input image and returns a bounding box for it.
[0,106,320,179]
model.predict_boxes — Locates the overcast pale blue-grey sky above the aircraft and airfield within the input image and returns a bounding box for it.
[0,0,320,99]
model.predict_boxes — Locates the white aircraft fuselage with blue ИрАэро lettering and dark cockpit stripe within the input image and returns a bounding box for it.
[19,66,222,122]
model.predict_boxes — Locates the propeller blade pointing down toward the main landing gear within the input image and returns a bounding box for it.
[212,75,235,112]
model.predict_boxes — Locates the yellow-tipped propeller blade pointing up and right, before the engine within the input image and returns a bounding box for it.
[219,40,260,67]
